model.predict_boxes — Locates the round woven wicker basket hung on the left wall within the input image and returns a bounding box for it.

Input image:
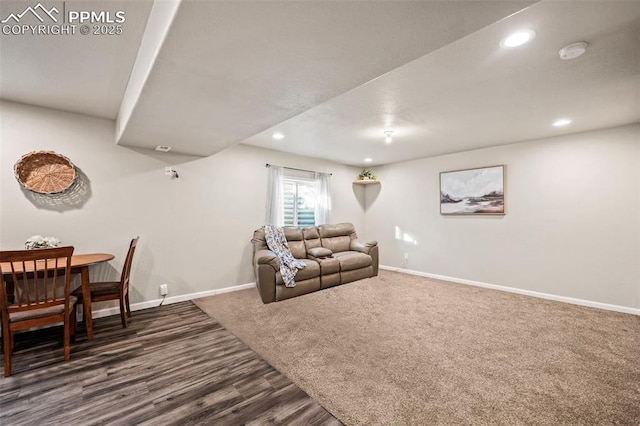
[13,151,78,194]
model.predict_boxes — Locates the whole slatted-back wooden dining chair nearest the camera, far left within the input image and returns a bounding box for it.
[0,247,76,377]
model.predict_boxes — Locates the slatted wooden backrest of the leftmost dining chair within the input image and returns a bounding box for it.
[0,247,73,315]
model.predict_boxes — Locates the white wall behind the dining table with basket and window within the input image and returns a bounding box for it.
[0,102,364,303]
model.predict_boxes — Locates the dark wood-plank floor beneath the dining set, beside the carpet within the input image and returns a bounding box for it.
[0,302,341,425]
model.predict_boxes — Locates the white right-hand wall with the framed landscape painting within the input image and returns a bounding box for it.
[365,125,640,309]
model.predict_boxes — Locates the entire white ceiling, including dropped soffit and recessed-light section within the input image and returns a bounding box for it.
[0,0,640,165]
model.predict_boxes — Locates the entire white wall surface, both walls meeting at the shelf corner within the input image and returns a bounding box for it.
[0,102,640,309]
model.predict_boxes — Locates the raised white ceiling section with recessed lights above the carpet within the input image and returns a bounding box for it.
[245,1,640,165]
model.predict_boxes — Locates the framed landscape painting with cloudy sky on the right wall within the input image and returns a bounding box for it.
[440,166,504,215]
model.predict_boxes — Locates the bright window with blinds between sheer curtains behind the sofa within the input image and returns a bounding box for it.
[283,177,316,227]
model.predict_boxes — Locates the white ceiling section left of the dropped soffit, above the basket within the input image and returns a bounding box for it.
[0,0,153,119]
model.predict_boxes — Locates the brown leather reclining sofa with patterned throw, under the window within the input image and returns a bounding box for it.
[251,223,378,303]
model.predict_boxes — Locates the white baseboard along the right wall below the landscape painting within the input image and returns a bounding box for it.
[380,265,640,316]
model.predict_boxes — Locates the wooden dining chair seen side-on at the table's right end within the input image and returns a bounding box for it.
[71,237,140,328]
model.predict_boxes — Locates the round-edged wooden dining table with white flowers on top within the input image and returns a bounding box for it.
[0,253,115,340]
